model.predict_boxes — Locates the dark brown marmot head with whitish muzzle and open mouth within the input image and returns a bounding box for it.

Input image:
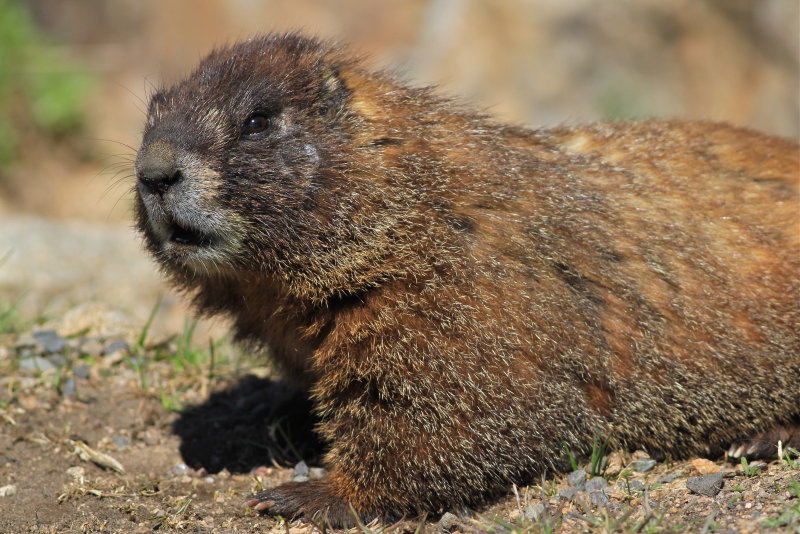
[136,35,412,298]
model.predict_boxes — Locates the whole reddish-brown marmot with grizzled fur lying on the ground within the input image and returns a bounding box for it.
[136,34,800,525]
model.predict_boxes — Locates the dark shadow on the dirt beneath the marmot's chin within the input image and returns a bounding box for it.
[173,375,324,473]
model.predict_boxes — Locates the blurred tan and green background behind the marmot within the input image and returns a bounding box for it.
[0,0,800,329]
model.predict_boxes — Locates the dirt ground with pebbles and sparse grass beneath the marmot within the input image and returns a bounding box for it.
[0,311,800,533]
